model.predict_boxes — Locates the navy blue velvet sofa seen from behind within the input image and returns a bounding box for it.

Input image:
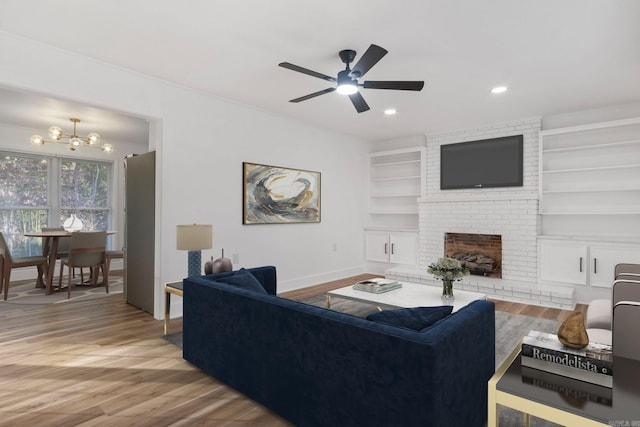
[183,266,495,427]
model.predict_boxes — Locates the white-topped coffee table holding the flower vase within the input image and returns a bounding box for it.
[327,282,487,312]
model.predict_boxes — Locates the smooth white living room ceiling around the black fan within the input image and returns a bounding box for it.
[0,0,640,140]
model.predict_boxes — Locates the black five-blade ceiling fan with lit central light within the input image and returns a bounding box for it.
[278,44,424,113]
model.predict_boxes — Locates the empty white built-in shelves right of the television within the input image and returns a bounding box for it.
[539,118,640,242]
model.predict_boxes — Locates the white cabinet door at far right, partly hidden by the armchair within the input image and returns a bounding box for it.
[589,246,640,288]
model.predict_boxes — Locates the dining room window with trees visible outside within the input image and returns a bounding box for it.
[0,153,113,256]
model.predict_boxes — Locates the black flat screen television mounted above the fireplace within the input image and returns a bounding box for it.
[440,135,523,190]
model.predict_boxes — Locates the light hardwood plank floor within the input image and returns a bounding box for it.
[0,275,584,427]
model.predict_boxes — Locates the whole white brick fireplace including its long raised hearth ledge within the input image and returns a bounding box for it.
[385,119,574,309]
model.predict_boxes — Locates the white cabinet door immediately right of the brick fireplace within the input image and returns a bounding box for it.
[538,240,588,285]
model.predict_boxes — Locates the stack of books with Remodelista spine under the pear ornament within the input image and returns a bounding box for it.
[520,331,613,388]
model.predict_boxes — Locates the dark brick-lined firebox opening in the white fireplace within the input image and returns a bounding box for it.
[444,233,502,278]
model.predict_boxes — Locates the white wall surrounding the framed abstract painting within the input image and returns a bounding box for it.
[0,32,368,318]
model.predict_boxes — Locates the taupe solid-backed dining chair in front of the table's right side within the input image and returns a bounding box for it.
[58,231,109,298]
